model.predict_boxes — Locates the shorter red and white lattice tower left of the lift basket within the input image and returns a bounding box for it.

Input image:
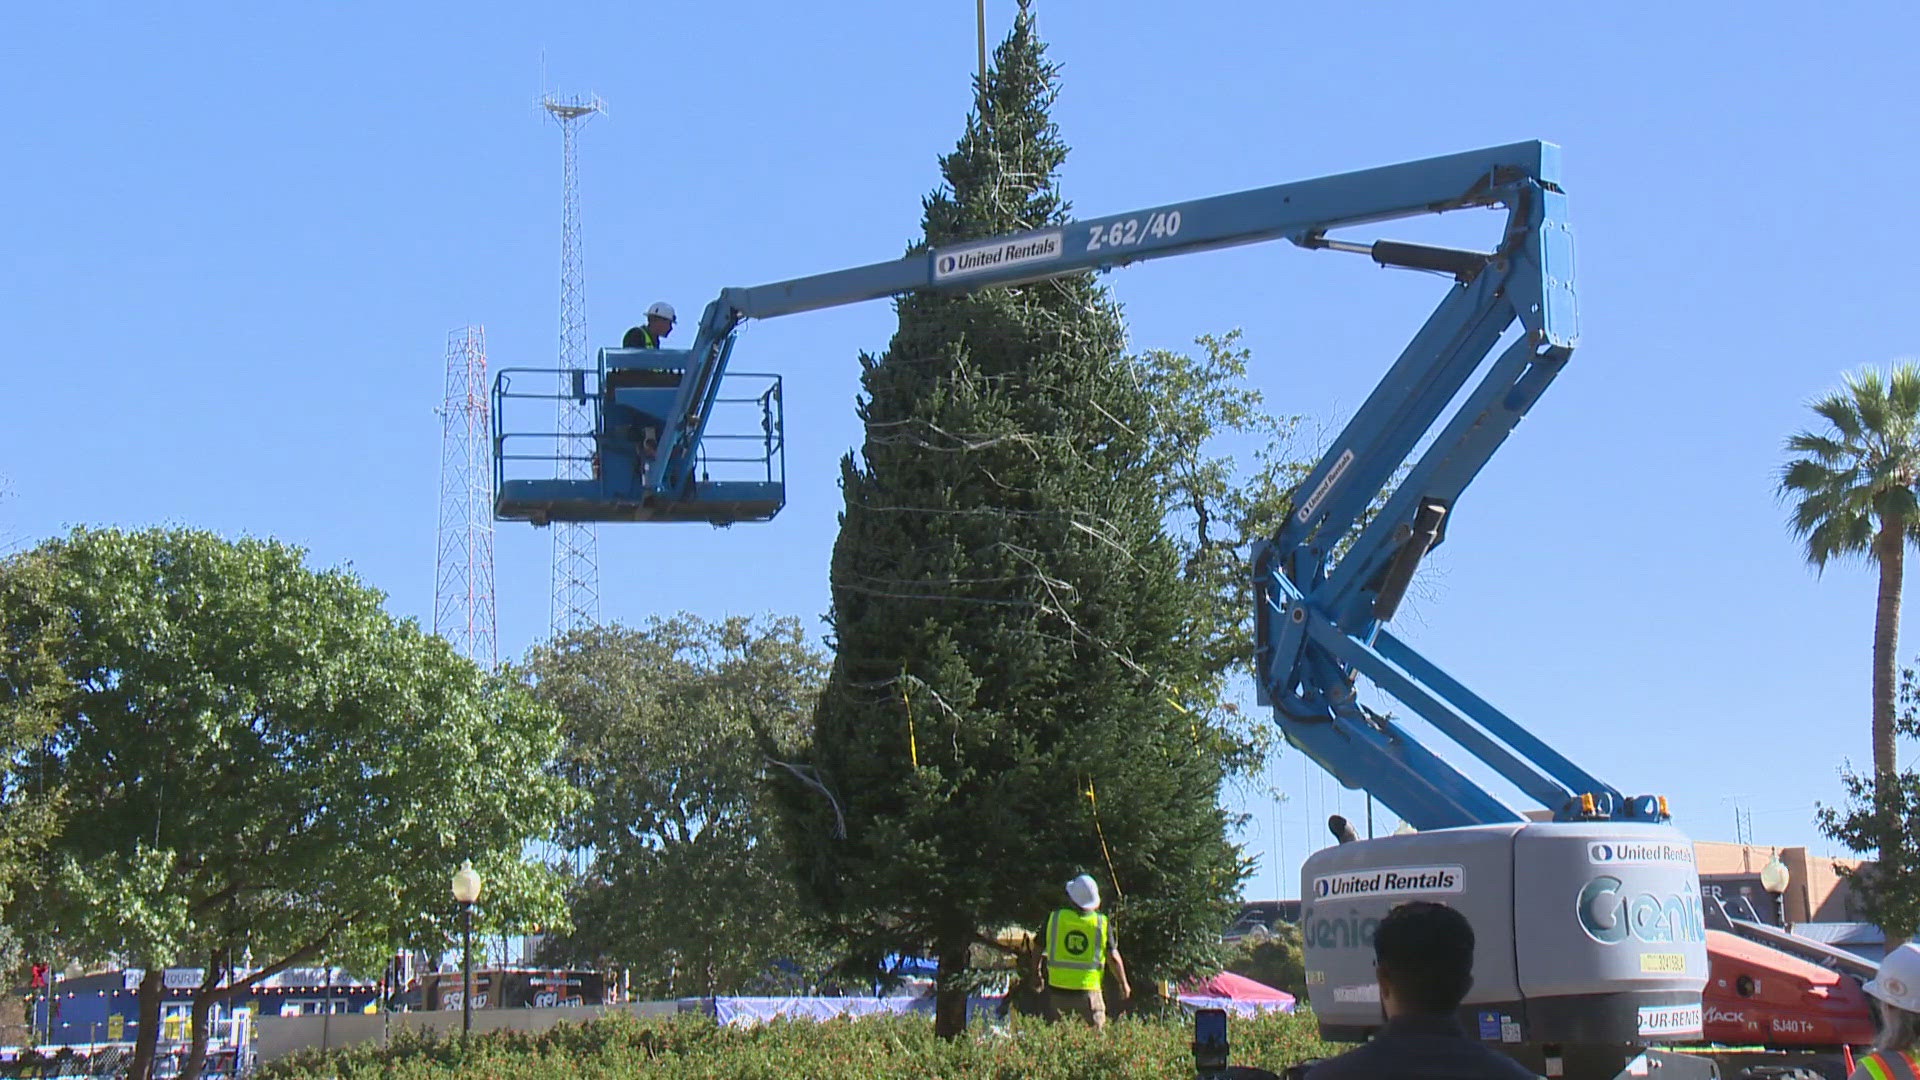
[434,327,499,671]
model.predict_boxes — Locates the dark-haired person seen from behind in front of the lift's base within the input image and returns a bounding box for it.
[1308,901,1538,1080]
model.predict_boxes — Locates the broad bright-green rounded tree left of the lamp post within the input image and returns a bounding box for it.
[0,528,572,1076]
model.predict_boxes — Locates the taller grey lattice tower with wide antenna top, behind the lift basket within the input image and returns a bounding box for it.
[540,94,607,638]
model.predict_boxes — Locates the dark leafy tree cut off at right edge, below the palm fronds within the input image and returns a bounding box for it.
[1820,657,1920,942]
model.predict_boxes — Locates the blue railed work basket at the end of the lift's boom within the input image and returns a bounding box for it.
[493,348,787,525]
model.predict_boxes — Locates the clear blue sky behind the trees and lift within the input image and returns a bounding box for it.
[0,0,1920,896]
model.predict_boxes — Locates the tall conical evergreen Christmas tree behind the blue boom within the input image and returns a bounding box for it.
[764,4,1254,1036]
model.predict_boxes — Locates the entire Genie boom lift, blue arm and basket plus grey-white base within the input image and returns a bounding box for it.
[495,142,1743,1080]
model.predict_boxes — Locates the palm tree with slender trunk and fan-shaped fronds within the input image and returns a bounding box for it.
[1780,361,1920,796]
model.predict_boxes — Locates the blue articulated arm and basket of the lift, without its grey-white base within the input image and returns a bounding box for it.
[493,142,1620,828]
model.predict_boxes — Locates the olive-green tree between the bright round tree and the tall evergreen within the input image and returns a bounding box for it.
[528,613,826,997]
